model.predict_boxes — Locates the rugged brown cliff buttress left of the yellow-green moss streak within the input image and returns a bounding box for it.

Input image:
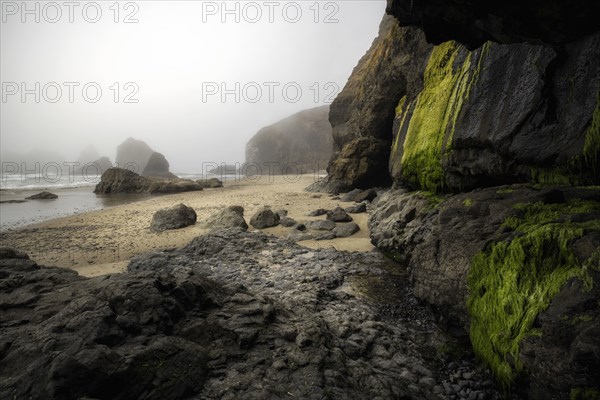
[326,16,433,192]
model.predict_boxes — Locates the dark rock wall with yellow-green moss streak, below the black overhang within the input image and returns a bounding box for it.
[390,34,600,192]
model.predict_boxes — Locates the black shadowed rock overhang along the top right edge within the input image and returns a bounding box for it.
[387,0,599,48]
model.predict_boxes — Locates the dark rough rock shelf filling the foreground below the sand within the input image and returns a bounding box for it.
[0,229,512,399]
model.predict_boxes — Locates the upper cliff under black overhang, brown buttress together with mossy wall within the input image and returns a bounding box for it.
[318,9,600,192]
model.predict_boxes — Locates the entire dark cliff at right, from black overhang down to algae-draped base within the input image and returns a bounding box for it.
[313,0,600,399]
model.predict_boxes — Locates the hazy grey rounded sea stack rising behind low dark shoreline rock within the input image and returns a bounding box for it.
[116,137,177,179]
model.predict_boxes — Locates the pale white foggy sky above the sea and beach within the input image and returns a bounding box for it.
[0,0,385,172]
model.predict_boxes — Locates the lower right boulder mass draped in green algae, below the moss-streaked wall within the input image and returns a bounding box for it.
[369,185,600,399]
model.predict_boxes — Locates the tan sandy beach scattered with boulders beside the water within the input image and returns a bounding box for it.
[0,175,373,276]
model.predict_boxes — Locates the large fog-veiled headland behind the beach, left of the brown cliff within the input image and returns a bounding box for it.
[246,106,333,175]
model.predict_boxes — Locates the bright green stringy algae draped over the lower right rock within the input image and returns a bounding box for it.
[467,200,600,388]
